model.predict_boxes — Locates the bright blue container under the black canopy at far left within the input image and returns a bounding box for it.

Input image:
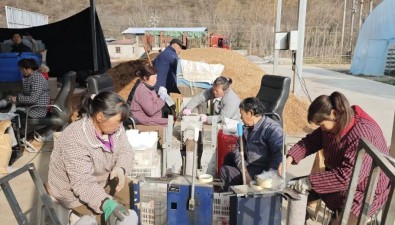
[0,52,41,83]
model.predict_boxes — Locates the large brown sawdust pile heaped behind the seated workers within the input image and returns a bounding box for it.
[108,48,312,135]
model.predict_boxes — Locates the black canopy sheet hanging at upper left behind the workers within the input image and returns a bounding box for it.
[0,6,111,81]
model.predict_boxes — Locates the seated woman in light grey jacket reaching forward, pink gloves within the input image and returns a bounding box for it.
[183,76,240,124]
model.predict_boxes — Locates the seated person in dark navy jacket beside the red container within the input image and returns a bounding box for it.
[220,97,284,190]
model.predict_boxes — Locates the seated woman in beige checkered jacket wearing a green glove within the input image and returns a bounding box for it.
[48,91,137,225]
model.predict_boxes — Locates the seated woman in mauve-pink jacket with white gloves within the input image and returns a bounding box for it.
[130,65,174,126]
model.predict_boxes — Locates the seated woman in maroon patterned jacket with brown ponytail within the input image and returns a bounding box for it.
[279,92,390,225]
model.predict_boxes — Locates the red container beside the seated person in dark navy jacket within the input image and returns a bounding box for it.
[217,129,237,177]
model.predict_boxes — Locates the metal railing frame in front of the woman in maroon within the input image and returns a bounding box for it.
[341,139,395,225]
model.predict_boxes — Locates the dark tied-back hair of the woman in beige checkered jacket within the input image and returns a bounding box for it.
[78,91,130,121]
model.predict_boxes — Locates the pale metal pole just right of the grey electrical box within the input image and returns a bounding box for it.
[294,0,307,96]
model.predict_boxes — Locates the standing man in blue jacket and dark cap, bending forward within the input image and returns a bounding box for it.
[154,39,186,93]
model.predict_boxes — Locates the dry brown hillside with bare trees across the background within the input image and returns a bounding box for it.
[0,0,380,57]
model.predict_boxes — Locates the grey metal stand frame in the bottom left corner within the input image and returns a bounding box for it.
[0,163,61,225]
